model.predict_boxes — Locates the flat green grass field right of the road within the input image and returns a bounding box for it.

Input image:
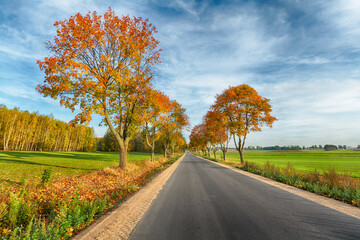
[212,150,360,177]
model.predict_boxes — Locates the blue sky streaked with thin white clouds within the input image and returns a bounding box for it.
[0,0,360,146]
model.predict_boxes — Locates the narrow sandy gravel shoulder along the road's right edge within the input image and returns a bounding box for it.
[194,155,360,219]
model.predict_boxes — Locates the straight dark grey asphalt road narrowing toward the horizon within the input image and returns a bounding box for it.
[129,153,360,240]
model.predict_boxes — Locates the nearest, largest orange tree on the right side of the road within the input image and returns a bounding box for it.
[213,84,276,163]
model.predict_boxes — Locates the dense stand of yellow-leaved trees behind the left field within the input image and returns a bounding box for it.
[0,105,96,152]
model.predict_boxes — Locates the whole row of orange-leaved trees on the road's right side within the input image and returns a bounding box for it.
[189,84,276,163]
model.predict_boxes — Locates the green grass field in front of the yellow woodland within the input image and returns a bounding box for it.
[0,151,162,183]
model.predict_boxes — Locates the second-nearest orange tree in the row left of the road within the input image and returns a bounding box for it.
[143,90,171,161]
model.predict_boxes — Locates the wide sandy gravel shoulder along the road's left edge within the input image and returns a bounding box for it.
[72,154,185,240]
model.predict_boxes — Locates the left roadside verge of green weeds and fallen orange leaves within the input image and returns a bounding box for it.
[0,158,177,239]
